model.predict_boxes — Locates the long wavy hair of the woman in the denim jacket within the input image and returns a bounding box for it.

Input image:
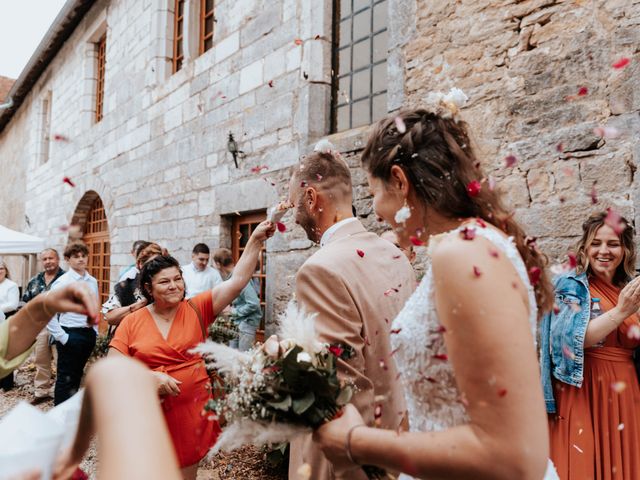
[576,212,636,287]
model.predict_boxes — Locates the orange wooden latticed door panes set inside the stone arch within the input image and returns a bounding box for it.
[82,197,111,330]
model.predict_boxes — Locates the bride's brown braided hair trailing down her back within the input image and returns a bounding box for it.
[362,109,554,316]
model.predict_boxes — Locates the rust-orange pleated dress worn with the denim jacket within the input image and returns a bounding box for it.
[549,277,640,480]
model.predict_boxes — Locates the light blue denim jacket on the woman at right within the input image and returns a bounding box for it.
[540,271,591,413]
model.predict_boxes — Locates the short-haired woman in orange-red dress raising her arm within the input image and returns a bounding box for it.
[109,221,275,480]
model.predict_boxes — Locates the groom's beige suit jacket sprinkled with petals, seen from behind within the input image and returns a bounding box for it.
[289,220,415,480]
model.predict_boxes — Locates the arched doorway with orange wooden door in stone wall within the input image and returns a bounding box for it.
[71,191,111,332]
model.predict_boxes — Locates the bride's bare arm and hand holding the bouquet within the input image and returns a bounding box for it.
[316,238,548,480]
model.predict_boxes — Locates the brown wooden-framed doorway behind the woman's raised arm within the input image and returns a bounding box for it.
[231,212,267,341]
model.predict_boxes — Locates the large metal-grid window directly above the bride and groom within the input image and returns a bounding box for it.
[331,0,388,132]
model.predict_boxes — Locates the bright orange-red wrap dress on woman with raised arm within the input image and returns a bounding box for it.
[110,291,220,467]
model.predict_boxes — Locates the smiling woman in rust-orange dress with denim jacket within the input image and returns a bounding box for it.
[542,212,640,480]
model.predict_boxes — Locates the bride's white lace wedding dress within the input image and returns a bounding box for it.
[391,226,558,480]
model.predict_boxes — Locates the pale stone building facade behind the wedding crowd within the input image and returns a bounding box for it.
[0,0,640,332]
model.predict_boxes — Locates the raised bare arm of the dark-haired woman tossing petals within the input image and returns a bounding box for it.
[211,220,276,315]
